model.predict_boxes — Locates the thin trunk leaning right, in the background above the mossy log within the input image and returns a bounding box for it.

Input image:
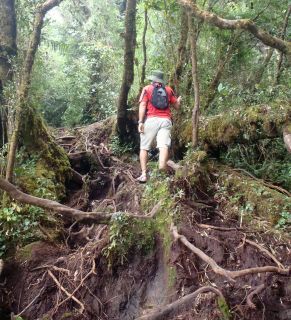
[204,35,238,110]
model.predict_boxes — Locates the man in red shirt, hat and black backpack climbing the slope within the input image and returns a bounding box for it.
[137,70,181,182]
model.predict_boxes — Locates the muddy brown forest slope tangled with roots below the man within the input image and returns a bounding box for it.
[0,120,291,320]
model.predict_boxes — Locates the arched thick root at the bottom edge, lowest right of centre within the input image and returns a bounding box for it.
[137,286,225,320]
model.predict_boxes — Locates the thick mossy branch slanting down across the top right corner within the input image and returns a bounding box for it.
[179,0,291,61]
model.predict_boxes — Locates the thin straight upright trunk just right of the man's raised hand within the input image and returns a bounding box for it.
[188,12,200,147]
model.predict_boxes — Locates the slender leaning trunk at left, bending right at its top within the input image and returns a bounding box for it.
[6,0,61,181]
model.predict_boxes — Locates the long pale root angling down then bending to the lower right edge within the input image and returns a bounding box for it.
[171,225,290,282]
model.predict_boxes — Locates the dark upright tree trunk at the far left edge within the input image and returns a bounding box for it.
[0,0,16,147]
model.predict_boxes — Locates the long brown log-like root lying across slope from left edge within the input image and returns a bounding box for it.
[0,178,161,224]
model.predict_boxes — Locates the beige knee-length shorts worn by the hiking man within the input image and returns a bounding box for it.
[140,117,172,150]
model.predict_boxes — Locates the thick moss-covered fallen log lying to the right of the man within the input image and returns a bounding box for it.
[179,102,291,150]
